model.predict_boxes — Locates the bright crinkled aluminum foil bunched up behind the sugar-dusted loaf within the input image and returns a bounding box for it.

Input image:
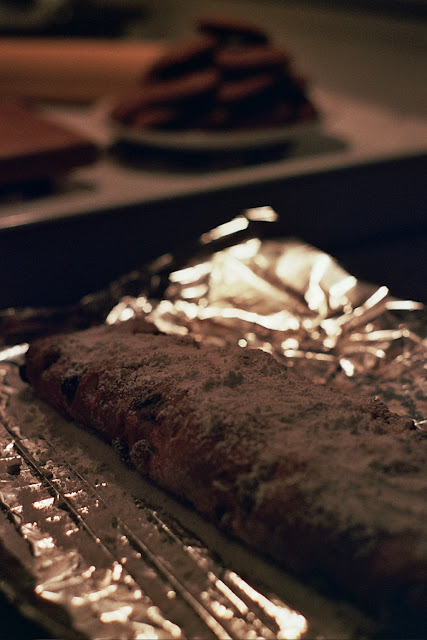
[106,207,427,428]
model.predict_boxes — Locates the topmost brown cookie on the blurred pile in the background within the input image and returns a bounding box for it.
[196,16,268,44]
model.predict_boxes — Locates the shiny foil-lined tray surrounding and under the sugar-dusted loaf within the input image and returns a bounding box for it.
[0,207,427,639]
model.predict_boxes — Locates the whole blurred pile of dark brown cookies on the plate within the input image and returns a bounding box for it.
[112,18,317,130]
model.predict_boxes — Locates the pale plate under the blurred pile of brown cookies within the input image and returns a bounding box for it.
[114,120,320,152]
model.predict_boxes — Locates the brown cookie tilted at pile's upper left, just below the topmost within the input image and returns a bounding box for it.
[145,36,217,80]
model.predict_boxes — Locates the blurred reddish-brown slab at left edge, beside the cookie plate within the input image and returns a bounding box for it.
[0,95,98,187]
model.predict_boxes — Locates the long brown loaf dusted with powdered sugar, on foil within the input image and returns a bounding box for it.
[26,321,427,628]
